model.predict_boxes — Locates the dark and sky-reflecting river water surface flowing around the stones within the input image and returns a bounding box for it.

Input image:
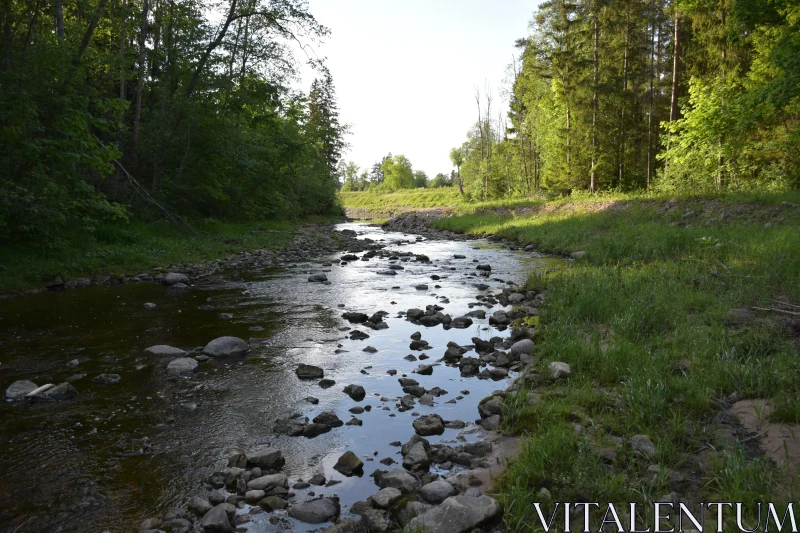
[0,223,558,533]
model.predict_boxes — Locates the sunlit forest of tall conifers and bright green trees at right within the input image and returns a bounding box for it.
[450,0,800,200]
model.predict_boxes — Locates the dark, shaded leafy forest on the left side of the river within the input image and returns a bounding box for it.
[0,0,347,243]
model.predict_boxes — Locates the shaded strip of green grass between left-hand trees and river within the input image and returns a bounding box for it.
[0,216,310,293]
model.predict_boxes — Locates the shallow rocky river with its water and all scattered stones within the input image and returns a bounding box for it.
[0,223,569,533]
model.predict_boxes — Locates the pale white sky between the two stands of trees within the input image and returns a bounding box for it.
[298,0,538,178]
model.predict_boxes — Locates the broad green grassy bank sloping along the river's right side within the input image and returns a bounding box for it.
[437,194,800,532]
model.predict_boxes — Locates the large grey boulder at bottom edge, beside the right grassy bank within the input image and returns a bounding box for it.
[406,495,502,533]
